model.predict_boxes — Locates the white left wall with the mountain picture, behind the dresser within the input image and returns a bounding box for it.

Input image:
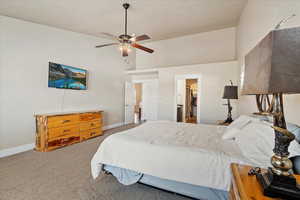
[0,16,134,149]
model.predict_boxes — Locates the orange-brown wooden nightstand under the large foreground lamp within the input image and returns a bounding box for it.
[229,164,300,200]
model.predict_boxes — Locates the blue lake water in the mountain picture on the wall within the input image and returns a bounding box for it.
[48,78,86,90]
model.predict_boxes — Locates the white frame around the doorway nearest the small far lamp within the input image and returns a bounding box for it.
[173,74,202,124]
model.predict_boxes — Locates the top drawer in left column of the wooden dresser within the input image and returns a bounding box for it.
[48,115,79,128]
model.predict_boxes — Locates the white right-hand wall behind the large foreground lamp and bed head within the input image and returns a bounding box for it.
[237,0,300,124]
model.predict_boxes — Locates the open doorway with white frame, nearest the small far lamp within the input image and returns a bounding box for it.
[174,74,201,123]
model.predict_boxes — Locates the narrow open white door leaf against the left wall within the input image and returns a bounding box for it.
[125,82,135,124]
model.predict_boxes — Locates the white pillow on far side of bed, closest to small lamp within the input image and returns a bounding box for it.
[222,115,259,140]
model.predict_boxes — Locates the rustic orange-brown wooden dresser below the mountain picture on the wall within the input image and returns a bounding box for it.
[35,111,103,152]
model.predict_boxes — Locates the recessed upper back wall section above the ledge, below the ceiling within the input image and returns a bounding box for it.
[136,28,236,69]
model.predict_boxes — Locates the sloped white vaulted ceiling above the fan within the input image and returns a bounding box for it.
[0,0,247,40]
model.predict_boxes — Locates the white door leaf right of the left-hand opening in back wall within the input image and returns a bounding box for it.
[142,80,158,120]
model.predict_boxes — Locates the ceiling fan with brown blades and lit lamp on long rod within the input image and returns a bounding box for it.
[96,3,154,57]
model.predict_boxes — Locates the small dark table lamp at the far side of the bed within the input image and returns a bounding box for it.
[222,80,238,125]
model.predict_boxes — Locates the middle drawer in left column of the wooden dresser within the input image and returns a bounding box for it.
[48,125,79,139]
